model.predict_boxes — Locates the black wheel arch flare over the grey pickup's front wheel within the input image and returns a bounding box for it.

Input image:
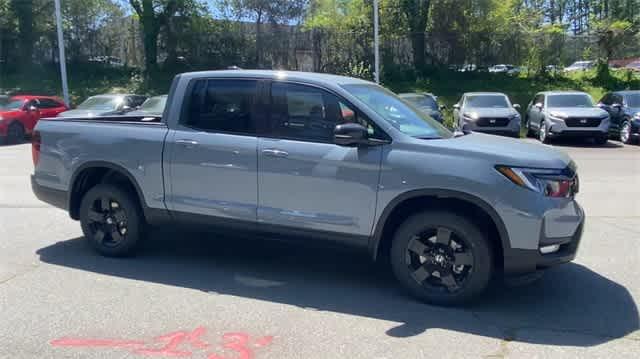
[369,189,511,261]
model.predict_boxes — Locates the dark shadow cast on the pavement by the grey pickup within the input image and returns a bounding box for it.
[38,232,639,346]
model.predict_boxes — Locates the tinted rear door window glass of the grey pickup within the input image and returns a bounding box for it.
[185,80,257,134]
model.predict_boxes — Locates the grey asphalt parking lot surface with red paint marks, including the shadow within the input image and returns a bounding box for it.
[0,140,640,359]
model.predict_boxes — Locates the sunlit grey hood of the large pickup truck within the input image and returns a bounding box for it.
[427,132,571,169]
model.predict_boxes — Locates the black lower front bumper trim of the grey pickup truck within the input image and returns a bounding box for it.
[504,207,585,276]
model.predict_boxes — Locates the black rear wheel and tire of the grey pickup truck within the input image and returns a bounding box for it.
[80,184,145,257]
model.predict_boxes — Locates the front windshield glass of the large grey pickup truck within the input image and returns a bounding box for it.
[342,85,453,139]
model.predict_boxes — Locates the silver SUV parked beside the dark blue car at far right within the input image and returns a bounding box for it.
[525,91,610,144]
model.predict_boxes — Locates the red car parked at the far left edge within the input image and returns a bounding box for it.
[0,95,69,144]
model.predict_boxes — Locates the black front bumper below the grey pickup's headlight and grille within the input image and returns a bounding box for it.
[504,203,585,276]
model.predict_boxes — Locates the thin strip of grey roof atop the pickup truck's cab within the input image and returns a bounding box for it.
[180,70,372,85]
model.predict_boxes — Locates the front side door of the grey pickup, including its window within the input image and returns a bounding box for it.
[258,82,384,236]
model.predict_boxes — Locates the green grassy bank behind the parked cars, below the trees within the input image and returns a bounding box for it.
[0,64,640,132]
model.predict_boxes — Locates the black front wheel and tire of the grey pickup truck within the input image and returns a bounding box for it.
[390,211,493,305]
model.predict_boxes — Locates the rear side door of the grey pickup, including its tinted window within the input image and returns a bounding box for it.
[166,79,258,224]
